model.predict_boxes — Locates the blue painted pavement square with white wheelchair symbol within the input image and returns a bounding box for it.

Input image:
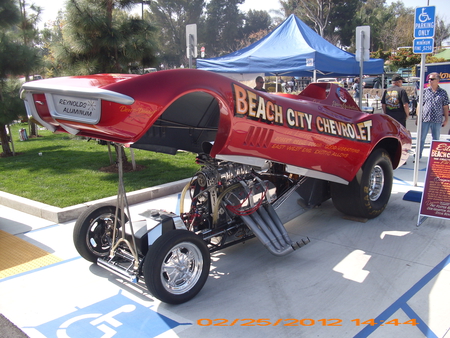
[28,294,192,338]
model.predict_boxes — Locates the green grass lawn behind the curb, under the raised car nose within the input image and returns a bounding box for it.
[0,124,199,208]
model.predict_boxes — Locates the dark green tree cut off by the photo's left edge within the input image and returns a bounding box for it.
[0,0,38,156]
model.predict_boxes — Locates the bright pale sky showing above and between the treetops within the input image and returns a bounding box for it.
[34,0,448,33]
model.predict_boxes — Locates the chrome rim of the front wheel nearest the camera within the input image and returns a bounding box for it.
[161,242,203,295]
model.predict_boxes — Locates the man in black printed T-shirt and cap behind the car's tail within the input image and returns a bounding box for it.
[381,75,409,127]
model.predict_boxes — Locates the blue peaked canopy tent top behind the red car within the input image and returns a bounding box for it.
[197,14,384,77]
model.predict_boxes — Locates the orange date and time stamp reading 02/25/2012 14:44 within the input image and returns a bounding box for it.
[197,318,419,326]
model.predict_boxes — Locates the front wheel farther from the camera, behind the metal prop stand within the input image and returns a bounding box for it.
[73,204,128,263]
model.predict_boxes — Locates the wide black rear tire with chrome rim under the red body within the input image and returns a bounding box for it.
[331,149,394,218]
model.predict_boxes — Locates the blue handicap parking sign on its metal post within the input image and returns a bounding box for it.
[413,6,436,187]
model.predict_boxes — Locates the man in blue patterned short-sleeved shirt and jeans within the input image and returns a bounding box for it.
[417,73,449,159]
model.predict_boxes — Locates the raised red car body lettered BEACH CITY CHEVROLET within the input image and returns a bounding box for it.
[22,69,411,184]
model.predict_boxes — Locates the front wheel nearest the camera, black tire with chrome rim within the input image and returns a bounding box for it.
[143,230,211,304]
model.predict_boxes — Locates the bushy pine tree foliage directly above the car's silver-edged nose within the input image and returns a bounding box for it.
[55,0,156,75]
